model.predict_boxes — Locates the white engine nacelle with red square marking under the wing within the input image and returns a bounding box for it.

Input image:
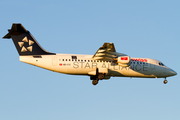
[114,56,131,67]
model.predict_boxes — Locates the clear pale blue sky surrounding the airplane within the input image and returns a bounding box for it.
[0,0,180,120]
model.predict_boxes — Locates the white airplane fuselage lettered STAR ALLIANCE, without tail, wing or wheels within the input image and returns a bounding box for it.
[20,54,175,78]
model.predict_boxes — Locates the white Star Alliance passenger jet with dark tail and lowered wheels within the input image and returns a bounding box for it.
[3,23,177,85]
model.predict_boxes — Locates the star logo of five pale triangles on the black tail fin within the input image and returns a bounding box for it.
[18,37,34,52]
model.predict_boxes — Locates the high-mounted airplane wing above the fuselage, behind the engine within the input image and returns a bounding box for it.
[93,43,126,60]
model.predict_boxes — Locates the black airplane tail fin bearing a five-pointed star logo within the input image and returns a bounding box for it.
[3,23,55,55]
